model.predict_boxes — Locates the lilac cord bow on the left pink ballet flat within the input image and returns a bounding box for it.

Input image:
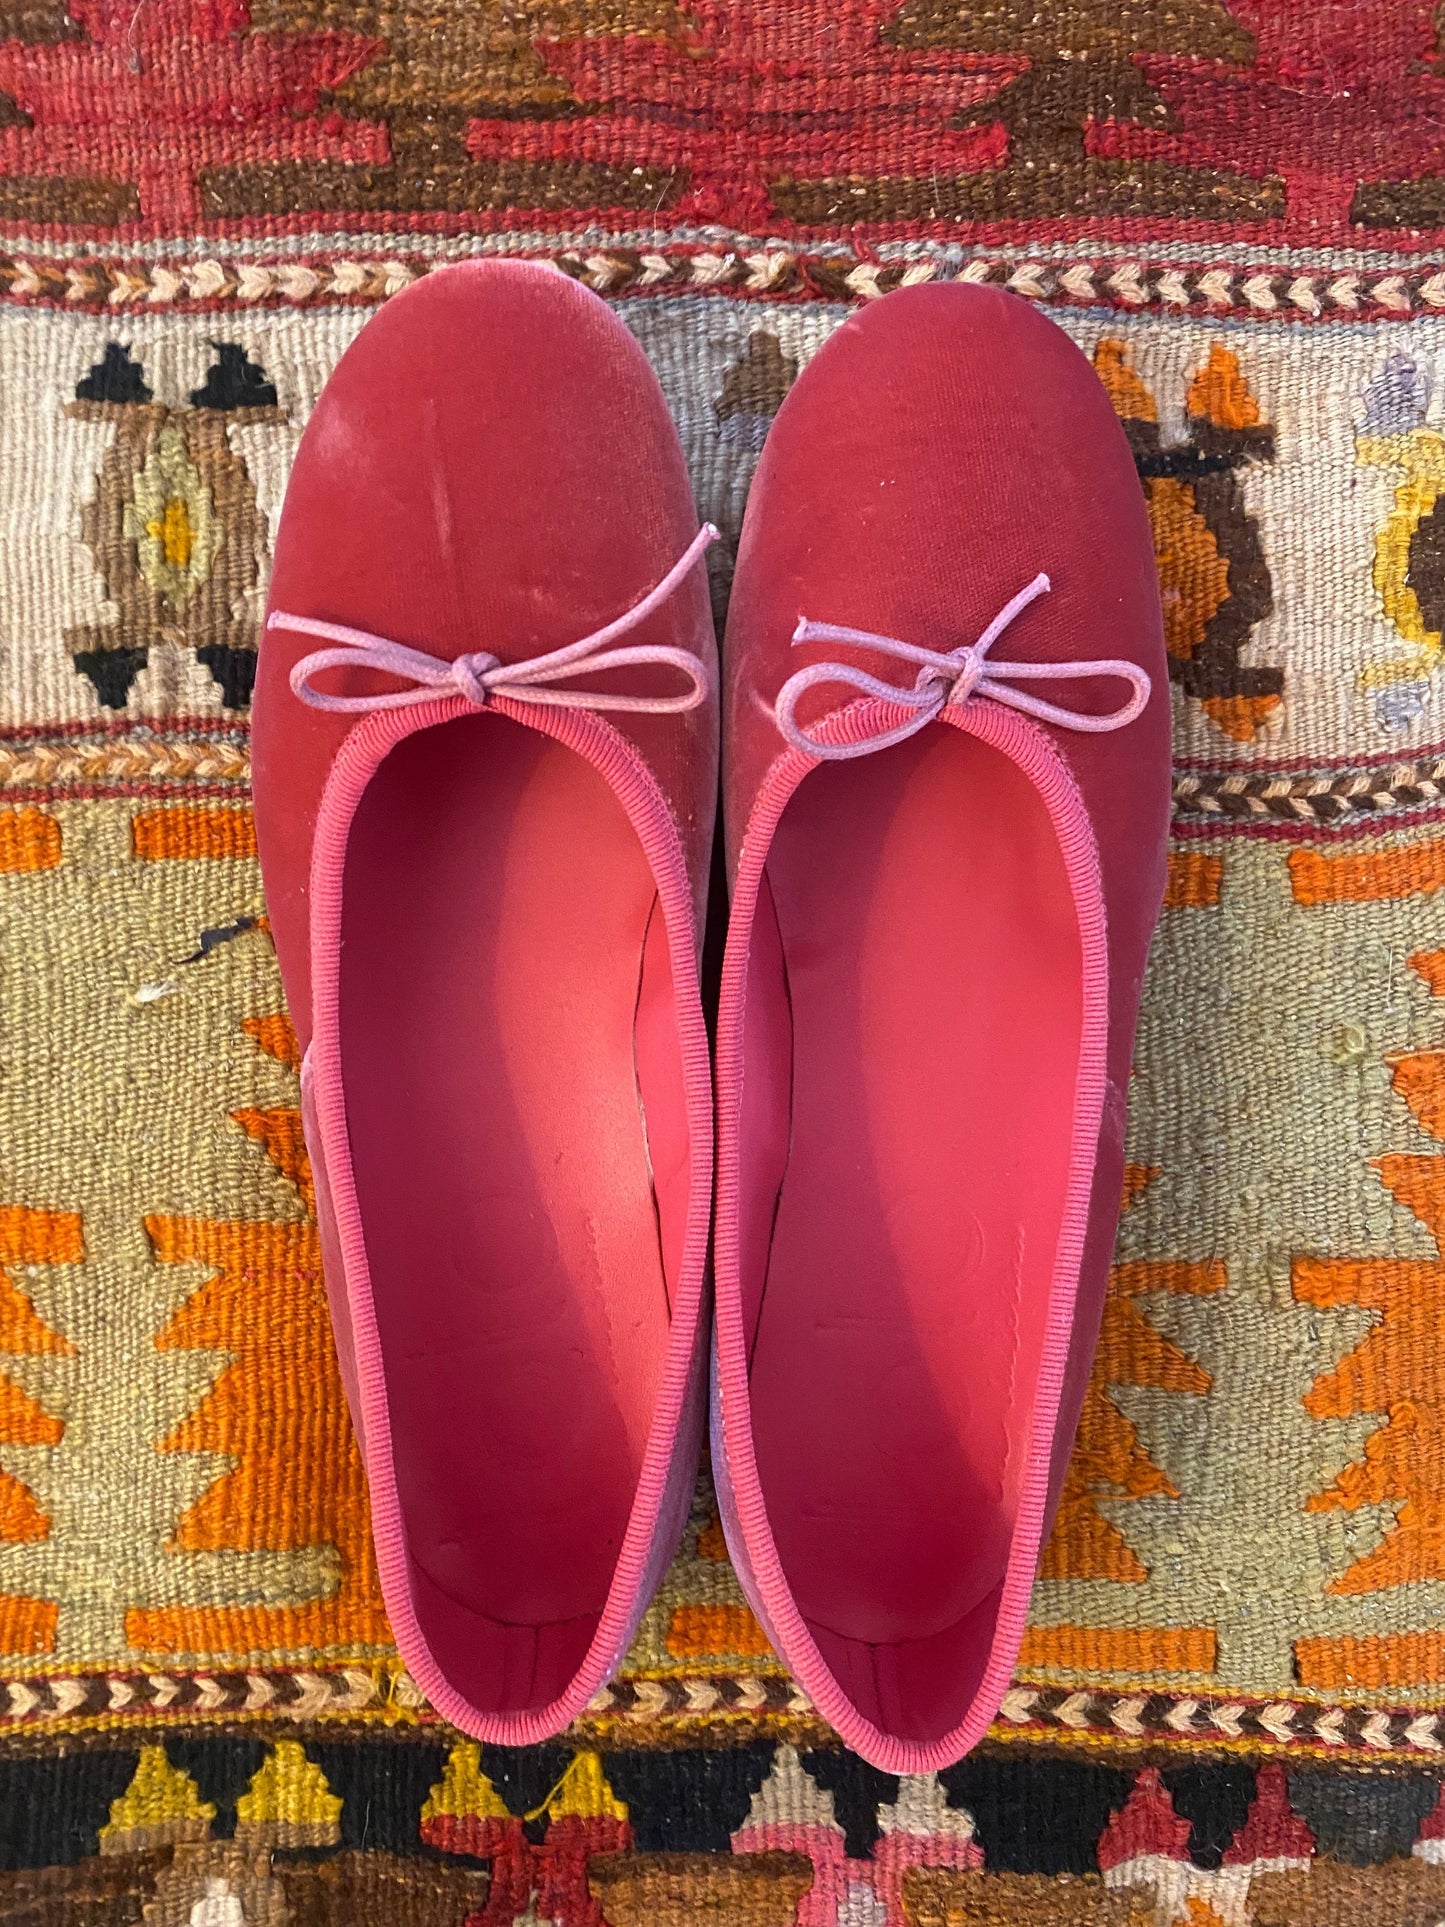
[266,522,719,715]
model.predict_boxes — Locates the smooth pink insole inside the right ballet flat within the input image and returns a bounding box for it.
[742,728,1081,1730]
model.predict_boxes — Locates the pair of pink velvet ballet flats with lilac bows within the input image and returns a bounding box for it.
[254,262,1169,1773]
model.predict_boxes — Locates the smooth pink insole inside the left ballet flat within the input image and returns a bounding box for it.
[341,715,686,1707]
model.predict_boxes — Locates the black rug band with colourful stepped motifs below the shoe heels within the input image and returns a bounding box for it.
[0,1736,1445,1927]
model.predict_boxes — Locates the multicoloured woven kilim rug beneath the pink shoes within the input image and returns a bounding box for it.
[0,0,1445,1927]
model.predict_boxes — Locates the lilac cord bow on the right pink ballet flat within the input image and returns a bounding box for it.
[773,574,1150,761]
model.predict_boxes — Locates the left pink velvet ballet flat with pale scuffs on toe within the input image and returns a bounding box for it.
[254,262,717,1742]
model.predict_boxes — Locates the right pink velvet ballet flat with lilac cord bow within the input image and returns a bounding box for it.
[713,283,1169,1773]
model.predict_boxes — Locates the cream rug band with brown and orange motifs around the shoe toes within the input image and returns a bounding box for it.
[0,297,1445,770]
